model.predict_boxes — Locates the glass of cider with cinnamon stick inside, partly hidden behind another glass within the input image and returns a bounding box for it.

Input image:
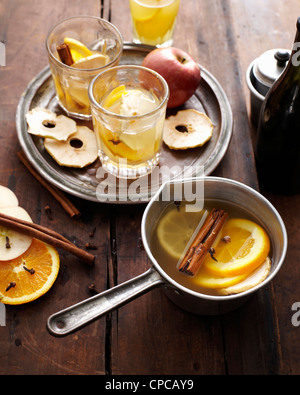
[46,16,123,120]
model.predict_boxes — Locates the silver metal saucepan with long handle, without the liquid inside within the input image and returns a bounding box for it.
[47,177,287,336]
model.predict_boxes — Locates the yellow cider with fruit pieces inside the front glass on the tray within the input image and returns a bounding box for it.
[94,88,165,168]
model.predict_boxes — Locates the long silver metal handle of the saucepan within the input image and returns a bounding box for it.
[47,267,165,336]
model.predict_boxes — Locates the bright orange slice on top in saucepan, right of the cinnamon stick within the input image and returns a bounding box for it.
[203,218,270,277]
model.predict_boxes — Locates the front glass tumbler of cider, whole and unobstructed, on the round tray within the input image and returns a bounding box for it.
[89,65,169,179]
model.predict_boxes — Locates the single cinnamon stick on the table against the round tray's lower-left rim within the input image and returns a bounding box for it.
[17,151,81,219]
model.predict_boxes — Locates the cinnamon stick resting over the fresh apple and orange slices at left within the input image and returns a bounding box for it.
[0,213,95,265]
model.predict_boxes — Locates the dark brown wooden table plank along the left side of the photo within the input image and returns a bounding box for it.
[0,1,110,374]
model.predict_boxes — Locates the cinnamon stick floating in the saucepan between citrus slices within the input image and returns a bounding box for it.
[178,209,228,276]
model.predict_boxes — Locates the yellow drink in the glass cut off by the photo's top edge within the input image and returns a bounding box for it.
[130,0,180,45]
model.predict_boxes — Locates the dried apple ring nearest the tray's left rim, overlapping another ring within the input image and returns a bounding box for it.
[26,107,76,141]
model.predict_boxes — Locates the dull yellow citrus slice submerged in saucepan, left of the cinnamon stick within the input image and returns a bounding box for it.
[157,207,204,260]
